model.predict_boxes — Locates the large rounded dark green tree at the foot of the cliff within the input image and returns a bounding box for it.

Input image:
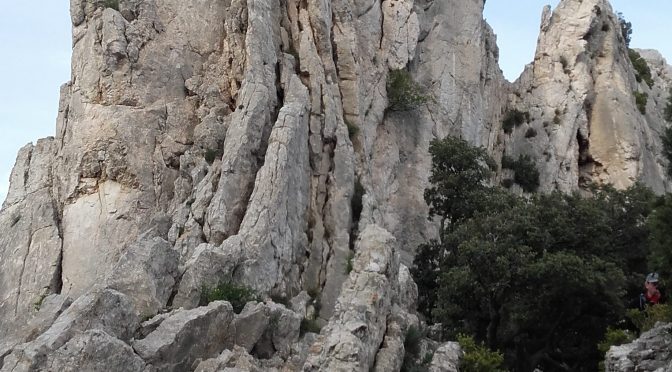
[433,193,625,371]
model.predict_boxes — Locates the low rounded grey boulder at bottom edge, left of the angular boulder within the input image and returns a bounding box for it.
[47,330,145,372]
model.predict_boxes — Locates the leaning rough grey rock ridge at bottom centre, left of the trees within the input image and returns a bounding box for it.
[303,225,399,371]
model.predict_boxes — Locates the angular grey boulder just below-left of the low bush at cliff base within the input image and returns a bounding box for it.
[133,301,234,371]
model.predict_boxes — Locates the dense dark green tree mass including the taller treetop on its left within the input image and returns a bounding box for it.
[412,139,660,371]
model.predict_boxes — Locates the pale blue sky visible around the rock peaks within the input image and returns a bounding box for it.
[0,0,672,202]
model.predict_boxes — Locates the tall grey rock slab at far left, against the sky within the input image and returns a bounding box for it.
[0,138,62,338]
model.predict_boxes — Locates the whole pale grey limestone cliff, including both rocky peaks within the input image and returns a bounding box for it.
[0,0,672,372]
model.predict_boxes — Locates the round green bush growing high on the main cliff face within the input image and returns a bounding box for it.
[387,69,429,111]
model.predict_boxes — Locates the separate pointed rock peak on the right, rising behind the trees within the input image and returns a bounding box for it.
[504,0,670,192]
